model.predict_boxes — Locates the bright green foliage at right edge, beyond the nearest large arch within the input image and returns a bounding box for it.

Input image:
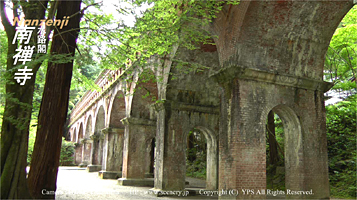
[325,6,357,198]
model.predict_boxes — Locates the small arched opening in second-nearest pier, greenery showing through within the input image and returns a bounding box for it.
[185,127,218,190]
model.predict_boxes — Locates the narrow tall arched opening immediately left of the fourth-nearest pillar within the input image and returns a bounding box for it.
[92,106,105,165]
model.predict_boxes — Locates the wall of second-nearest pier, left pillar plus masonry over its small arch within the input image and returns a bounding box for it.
[155,101,219,190]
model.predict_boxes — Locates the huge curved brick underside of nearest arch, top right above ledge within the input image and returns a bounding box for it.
[213,0,353,77]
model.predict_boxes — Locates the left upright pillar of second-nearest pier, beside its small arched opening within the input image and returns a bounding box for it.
[154,101,189,190]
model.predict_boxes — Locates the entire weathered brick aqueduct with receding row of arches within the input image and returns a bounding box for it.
[69,0,356,199]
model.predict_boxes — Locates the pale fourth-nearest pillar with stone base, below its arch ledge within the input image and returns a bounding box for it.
[99,128,124,179]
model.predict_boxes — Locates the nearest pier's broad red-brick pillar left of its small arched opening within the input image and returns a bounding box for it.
[214,76,266,199]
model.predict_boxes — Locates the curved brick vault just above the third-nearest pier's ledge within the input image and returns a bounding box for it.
[130,69,158,119]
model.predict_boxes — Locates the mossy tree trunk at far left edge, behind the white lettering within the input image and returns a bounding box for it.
[0,1,47,199]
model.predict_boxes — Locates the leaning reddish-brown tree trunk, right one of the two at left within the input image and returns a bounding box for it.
[28,1,81,199]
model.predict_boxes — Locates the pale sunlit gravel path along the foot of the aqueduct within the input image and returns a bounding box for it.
[56,167,217,200]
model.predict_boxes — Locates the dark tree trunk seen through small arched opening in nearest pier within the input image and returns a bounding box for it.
[267,111,279,165]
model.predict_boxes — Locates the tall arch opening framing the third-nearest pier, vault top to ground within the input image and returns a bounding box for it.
[120,70,158,180]
